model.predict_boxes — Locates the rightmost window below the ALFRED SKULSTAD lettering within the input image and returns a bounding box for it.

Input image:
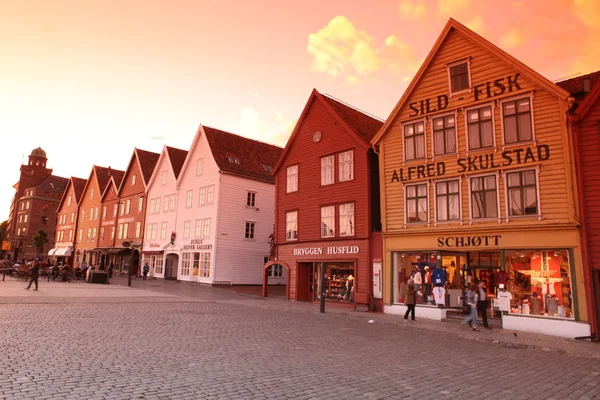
[506,170,539,217]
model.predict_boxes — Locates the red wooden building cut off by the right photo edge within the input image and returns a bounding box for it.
[558,71,600,341]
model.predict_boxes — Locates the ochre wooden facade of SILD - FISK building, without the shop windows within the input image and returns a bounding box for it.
[372,19,589,338]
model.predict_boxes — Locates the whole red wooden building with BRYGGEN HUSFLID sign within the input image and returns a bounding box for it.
[263,90,383,308]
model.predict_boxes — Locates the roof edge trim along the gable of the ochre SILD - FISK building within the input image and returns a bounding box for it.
[371,18,569,144]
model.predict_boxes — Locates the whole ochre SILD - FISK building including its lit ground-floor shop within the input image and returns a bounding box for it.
[372,20,590,337]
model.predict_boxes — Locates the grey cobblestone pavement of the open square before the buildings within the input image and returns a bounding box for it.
[0,281,600,400]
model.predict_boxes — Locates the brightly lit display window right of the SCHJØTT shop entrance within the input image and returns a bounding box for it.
[506,250,573,318]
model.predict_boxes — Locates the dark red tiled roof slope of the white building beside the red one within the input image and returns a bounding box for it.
[204,126,283,183]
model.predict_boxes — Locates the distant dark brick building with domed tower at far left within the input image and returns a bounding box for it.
[8,147,68,259]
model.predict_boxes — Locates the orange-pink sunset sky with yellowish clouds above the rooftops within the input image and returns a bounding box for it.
[0,0,600,221]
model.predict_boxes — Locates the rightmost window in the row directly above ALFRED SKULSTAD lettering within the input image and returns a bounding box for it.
[502,97,533,144]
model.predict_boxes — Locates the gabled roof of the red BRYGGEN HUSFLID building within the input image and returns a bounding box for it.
[273,89,383,174]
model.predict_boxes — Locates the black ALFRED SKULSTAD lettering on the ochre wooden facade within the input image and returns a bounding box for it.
[392,144,550,183]
